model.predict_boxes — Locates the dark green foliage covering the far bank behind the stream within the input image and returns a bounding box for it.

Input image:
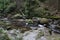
[0,0,60,18]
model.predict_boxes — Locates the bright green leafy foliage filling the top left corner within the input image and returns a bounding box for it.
[0,0,16,16]
